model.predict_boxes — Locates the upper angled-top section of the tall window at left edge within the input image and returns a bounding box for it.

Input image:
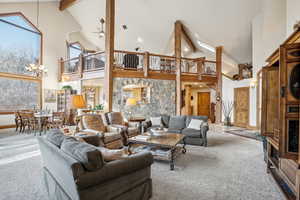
[0,13,42,75]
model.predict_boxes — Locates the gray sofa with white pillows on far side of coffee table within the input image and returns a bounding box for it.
[143,115,209,147]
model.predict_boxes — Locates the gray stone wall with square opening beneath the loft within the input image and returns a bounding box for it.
[113,78,176,119]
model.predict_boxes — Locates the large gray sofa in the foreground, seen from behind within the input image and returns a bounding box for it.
[38,132,153,200]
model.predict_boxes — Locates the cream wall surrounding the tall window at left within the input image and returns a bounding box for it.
[0,2,81,125]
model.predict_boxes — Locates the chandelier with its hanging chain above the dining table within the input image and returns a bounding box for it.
[25,0,48,77]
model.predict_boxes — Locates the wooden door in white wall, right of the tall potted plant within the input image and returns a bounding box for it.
[234,87,249,128]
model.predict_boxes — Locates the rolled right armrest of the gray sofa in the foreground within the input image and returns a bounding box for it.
[76,152,153,190]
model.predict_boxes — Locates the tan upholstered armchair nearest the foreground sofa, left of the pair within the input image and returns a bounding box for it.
[79,114,123,149]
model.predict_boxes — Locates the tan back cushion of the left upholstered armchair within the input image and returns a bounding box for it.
[82,115,106,132]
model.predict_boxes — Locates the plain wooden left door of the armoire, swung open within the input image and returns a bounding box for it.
[261,67,280,142]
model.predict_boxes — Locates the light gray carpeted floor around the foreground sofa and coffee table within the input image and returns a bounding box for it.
[0,130,284,200]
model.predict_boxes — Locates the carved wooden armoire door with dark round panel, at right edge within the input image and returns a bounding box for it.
[279,43,300,161]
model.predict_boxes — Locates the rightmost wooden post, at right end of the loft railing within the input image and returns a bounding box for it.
[216,46,223,123]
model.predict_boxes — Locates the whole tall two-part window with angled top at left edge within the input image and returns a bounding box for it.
[0,13,42,113]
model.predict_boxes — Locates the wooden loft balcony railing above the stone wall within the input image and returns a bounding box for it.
[58,50,217,83]
